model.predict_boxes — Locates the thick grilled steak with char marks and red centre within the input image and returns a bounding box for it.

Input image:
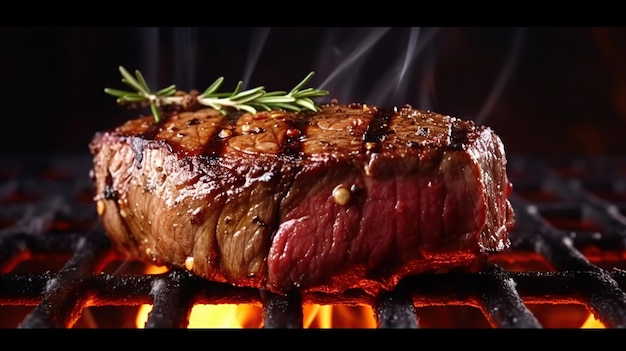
[90,103,514,293]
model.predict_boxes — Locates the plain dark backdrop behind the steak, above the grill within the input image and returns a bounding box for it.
[0,27,626,155]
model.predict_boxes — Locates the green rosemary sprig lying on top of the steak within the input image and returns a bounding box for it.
[104,66,328,123]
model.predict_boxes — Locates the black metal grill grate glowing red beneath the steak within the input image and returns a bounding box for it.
[0,155,626,328]
